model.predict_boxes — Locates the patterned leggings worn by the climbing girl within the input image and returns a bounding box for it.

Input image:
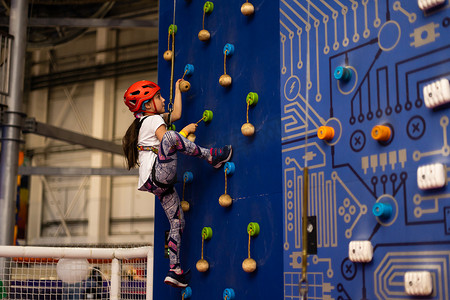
[145,130,211,269]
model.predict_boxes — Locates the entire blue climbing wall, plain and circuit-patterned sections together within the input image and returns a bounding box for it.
[154,0,450,299]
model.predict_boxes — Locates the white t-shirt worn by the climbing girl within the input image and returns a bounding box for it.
[138,115,166,191]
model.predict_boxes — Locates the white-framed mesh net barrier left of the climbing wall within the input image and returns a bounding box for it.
[0,246,153,299]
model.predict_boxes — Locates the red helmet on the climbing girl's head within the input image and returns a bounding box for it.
[123,80,161,113]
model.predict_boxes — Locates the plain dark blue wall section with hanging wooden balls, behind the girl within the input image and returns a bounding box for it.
[154,0,283,300]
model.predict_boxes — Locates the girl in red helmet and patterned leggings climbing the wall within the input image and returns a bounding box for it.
[122,79,232,287]
